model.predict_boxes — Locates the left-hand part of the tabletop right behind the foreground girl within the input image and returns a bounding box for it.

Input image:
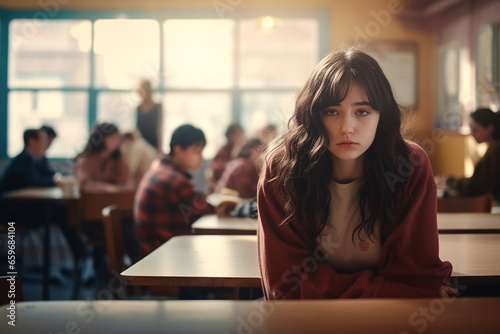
[121,235,260,288]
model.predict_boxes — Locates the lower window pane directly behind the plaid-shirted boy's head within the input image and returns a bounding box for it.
[163,93,231,159]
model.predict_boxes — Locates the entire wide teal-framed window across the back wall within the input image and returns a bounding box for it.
[0,12,327,159]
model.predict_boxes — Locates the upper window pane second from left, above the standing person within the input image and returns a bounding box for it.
[94,19,160,89]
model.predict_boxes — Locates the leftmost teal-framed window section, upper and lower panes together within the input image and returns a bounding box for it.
[7,19,91,157]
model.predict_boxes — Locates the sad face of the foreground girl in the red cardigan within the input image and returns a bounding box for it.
[321,83,380,160]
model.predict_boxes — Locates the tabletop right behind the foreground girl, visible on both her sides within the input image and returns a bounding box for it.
[121,234,500,287]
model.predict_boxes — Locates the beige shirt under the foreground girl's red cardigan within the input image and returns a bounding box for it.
[317,179,382,273]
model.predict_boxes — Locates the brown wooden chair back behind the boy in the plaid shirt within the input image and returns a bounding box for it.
[102,204,132,273]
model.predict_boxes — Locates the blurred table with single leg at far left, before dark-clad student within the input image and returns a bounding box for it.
[2,187,79,300]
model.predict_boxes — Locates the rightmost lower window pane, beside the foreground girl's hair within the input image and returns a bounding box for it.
[241,92,296,136]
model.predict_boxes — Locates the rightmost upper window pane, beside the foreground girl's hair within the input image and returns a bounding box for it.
[238,16,319,88]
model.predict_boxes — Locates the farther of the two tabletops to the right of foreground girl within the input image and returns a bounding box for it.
[437,213,500,233]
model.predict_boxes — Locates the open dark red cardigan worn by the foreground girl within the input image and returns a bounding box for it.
[257,143,452,300]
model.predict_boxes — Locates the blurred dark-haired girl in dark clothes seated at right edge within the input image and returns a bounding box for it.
[446,108,500,206]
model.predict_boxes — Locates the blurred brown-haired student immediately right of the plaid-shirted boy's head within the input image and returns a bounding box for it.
[205,123,244,194]
